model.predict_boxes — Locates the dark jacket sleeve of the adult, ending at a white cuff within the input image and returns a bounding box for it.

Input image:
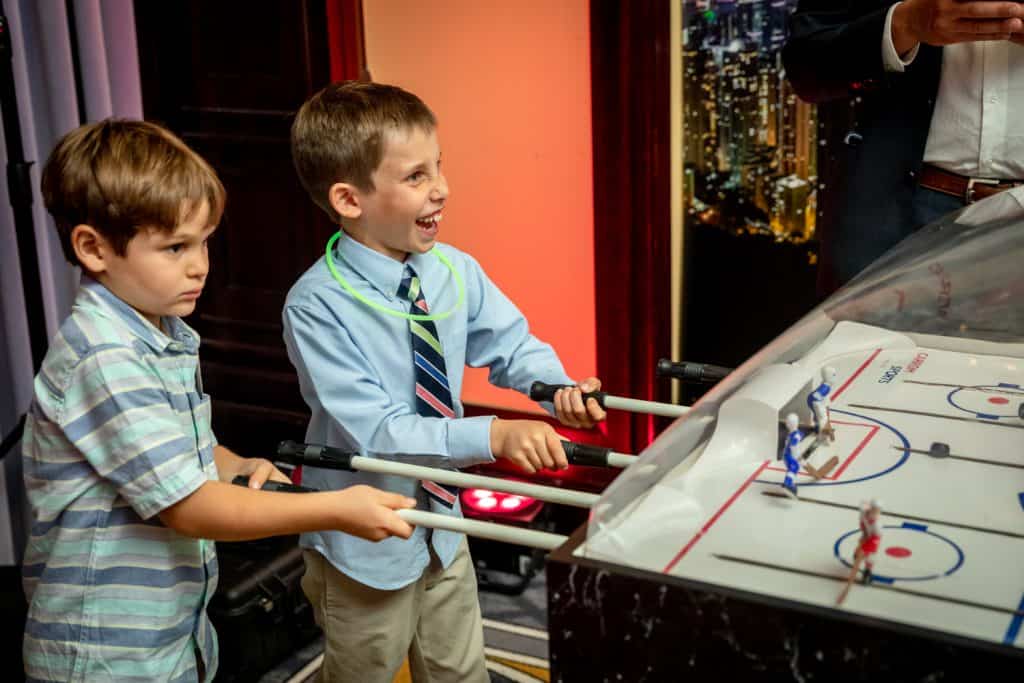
[782,0,895,103]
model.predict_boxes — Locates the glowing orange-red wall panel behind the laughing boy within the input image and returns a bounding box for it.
[362,0,598,411]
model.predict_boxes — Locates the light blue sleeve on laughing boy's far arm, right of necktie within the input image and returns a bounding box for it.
[466,255,573,413]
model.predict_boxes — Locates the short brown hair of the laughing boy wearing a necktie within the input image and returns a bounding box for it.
[292,81,437,223]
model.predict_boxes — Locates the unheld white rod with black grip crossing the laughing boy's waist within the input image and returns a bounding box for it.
[278,441,600,508]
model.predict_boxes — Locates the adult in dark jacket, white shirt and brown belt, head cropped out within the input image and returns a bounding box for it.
[782,0,1024,295]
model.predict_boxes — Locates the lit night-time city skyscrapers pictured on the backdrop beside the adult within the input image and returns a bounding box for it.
[682,0,817,243]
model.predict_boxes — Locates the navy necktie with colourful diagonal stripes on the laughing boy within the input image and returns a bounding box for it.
[398,263,459,510]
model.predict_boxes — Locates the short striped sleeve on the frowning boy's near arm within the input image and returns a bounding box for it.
[58,346,207,519]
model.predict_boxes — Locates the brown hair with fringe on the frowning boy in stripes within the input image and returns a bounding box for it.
[42,119,225,265]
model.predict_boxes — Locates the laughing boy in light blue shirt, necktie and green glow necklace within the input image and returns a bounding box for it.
[284,83,604,683]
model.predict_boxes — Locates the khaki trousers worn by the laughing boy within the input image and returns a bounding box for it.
[302,540,490,683]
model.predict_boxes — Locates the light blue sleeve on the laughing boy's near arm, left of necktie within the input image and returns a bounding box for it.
[284,306,494,468]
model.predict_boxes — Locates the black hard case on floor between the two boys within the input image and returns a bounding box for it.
[209,536,321,683]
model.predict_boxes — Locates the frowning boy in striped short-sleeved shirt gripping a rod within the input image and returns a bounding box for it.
[23,120,415,683]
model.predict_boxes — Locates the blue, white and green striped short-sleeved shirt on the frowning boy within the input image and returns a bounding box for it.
[23,276,217,683]
